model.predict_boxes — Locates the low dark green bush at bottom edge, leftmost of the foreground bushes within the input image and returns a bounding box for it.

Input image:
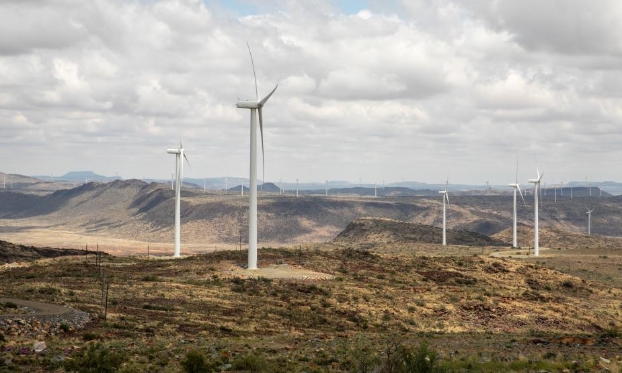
[65,343,127,373]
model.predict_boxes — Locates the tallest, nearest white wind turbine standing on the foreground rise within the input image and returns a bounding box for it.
[236,43,278,269]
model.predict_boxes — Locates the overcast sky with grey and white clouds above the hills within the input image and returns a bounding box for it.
[0,0,622,184]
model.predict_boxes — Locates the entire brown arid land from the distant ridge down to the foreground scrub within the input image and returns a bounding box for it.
[0,181,622,372]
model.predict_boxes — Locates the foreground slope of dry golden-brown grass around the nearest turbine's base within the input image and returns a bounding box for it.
[0,240,622,372]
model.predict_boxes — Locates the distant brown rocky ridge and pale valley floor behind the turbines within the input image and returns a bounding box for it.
[0,180,622,245]
